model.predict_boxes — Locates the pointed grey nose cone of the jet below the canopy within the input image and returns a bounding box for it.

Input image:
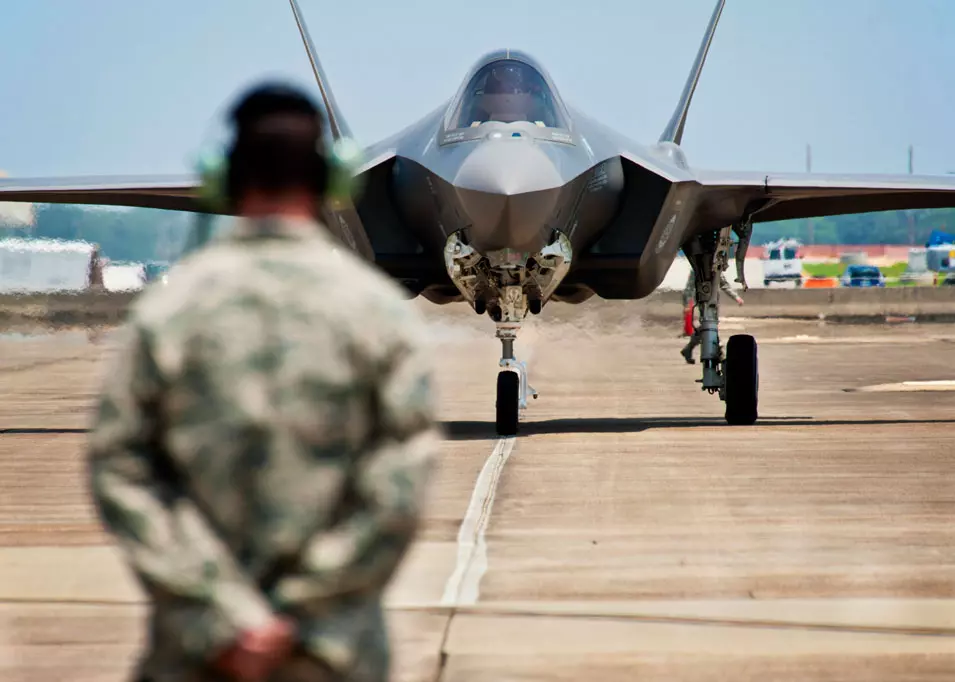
[454,139,561,252]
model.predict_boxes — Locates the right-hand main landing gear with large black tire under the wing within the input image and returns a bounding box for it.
[684,221,759,426]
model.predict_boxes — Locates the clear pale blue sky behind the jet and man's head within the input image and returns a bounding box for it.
[0,0,955,177]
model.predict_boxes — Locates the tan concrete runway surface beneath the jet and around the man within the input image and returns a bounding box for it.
[0,302,955,682]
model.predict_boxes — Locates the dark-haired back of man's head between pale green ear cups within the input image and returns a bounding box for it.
[227,83,328,201]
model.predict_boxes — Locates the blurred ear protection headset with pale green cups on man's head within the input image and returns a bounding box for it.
[196,84,361,213]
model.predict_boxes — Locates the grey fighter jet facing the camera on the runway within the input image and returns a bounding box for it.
[0,0,955,436]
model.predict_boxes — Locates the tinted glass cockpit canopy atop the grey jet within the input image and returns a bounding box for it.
[448,59,568,129]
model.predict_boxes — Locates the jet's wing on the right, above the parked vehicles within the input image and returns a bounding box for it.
[694,171,955,227]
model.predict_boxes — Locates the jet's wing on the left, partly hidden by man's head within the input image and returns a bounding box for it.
[0,175,205,212]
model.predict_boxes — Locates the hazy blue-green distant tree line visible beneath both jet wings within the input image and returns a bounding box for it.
[0,204,955,262]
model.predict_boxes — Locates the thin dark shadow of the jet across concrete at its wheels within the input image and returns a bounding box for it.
[442,417,955,440]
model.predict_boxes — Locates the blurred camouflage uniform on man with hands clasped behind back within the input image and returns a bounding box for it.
[89,219,440,682]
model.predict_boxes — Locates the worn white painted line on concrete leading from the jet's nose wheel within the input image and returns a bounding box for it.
[441,438,515,606]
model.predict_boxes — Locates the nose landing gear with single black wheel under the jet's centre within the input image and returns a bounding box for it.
[494,286,537,436]
